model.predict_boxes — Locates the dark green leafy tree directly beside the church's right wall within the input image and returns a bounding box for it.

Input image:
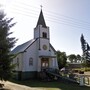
[57,51,67,69]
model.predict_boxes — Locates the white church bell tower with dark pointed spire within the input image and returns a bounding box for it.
[34,9,50,50]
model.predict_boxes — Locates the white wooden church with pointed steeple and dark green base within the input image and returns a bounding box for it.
[12,10,58,79]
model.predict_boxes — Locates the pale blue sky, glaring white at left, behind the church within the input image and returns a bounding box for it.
[0,0,90,55]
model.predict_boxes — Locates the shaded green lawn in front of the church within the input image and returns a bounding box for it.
[12,80,90,90]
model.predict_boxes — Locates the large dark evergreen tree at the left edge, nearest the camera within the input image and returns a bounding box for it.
[0,11,17,81]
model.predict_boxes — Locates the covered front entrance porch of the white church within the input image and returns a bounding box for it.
[37,56,58,72]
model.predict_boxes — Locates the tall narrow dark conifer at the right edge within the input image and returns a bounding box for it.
[80,34,90,67]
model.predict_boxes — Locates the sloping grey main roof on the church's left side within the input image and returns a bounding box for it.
[11,39,36,54]
